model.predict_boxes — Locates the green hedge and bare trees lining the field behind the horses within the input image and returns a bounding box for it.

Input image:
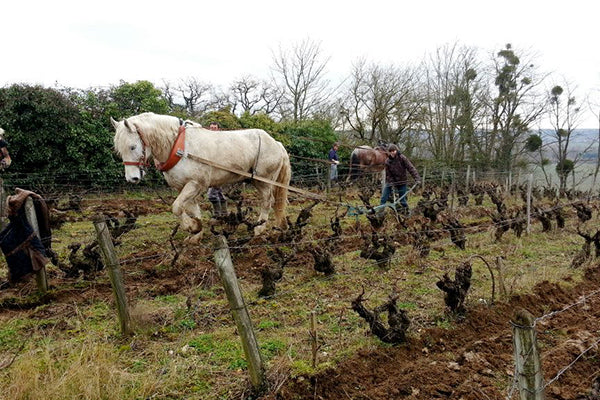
[0,40,596,193]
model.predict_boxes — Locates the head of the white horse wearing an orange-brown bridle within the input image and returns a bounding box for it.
[110,117,149,183]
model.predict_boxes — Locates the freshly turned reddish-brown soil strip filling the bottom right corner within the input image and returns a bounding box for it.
[264,266,600,400]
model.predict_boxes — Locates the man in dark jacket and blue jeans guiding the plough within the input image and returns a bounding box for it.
[381,144,421,215]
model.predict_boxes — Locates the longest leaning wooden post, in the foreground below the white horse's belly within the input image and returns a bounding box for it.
[215,235,267,393]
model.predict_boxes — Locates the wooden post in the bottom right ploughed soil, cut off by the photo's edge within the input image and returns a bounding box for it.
[512,309,544,400]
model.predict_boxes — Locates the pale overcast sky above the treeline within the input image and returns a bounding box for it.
[0,0,600,128]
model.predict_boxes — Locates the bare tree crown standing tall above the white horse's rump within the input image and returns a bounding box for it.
[272,39,330,122]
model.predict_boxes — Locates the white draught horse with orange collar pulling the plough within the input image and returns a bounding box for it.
[111,113,291,235]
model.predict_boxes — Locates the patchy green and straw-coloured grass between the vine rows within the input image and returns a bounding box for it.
[0,189,582,400]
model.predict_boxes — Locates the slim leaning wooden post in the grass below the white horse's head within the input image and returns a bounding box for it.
[94,215,132,335]
